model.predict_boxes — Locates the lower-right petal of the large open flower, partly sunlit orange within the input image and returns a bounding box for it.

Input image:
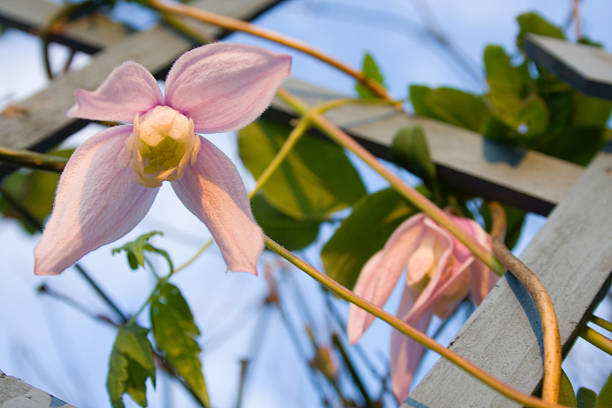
[172,138,263,274]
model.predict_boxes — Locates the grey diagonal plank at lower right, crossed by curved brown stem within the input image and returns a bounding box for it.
[404,153,612,408]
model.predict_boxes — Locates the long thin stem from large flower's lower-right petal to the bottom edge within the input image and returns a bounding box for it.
[265,236,561,408]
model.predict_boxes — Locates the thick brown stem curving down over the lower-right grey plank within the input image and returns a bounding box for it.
[489,202,562,402]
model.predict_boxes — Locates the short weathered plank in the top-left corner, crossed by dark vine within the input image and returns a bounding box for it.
[0,0,127,53]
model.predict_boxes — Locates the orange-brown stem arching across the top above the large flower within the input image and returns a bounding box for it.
[149,0,390,100]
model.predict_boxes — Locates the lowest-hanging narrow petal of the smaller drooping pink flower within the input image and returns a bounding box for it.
[389,288,431,403]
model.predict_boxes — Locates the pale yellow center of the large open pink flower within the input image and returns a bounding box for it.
[126,106,200,187]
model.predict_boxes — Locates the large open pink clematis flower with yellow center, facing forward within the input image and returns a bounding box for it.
[34,43,291,275]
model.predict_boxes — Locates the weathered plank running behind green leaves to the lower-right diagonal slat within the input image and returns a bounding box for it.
[273,79,582,214]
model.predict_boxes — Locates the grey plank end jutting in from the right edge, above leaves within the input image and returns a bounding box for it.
[525,34,612,99]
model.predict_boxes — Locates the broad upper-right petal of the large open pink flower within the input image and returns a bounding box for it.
[166,43,291,133]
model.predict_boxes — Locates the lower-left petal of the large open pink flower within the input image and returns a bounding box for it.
[34,126,157,275]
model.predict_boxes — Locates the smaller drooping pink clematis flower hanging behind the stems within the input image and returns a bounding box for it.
[347,214,498,402]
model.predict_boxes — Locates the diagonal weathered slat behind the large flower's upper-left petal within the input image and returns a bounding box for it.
[0,0,278,164]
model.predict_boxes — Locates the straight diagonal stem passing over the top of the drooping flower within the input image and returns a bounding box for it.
[277,88,505,276]
